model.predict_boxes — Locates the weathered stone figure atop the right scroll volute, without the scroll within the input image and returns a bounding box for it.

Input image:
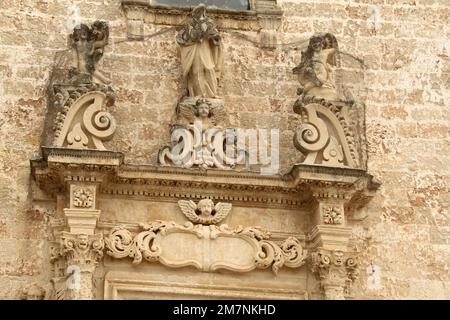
[293,33,339,101]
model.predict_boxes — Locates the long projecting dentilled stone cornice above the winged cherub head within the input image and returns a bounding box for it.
[31,147,378,208]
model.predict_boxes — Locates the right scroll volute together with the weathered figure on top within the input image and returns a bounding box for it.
[293,34,365,168]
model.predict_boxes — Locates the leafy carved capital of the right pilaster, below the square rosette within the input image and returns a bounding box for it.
[311,248,358,300]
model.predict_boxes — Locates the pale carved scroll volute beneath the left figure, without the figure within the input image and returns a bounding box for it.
[54,91,116,150]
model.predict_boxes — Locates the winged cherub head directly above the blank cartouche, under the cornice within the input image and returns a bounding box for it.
[178,199,231,225]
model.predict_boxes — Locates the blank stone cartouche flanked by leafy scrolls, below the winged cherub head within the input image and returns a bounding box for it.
[105,221,306,274]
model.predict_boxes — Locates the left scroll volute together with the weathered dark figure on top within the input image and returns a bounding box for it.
[45,21,116,150]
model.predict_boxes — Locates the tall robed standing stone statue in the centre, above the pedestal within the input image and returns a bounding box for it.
[176,4,223,98]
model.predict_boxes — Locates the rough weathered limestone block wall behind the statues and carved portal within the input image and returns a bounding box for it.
[0,0,450,299]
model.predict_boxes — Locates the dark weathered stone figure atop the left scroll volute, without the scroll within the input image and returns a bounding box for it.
[70,21,111,84]
